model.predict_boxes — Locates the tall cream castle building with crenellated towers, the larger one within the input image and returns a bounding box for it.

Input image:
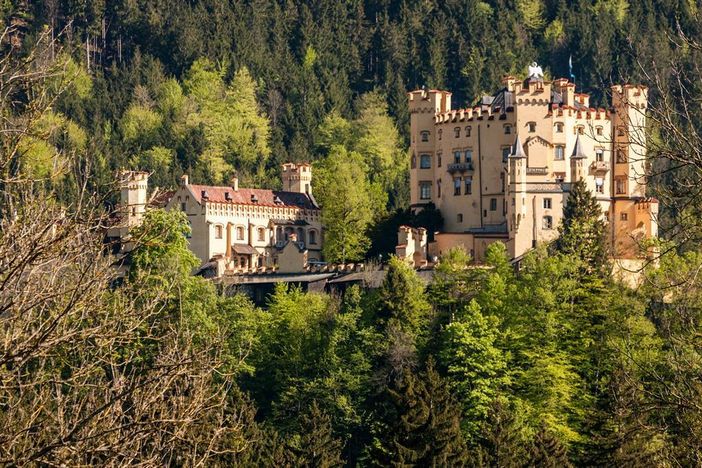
[409,66,658,260]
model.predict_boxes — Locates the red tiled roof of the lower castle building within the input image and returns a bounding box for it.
[188,185,317,209]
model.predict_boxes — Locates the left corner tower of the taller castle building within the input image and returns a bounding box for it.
[408,89,451,207]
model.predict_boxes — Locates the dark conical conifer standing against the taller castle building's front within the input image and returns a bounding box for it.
[557,180,607,271]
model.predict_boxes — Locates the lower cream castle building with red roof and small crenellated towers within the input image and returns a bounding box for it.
[108,163,323,273]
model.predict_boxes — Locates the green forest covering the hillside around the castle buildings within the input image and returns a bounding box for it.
[0,0,702,467]
